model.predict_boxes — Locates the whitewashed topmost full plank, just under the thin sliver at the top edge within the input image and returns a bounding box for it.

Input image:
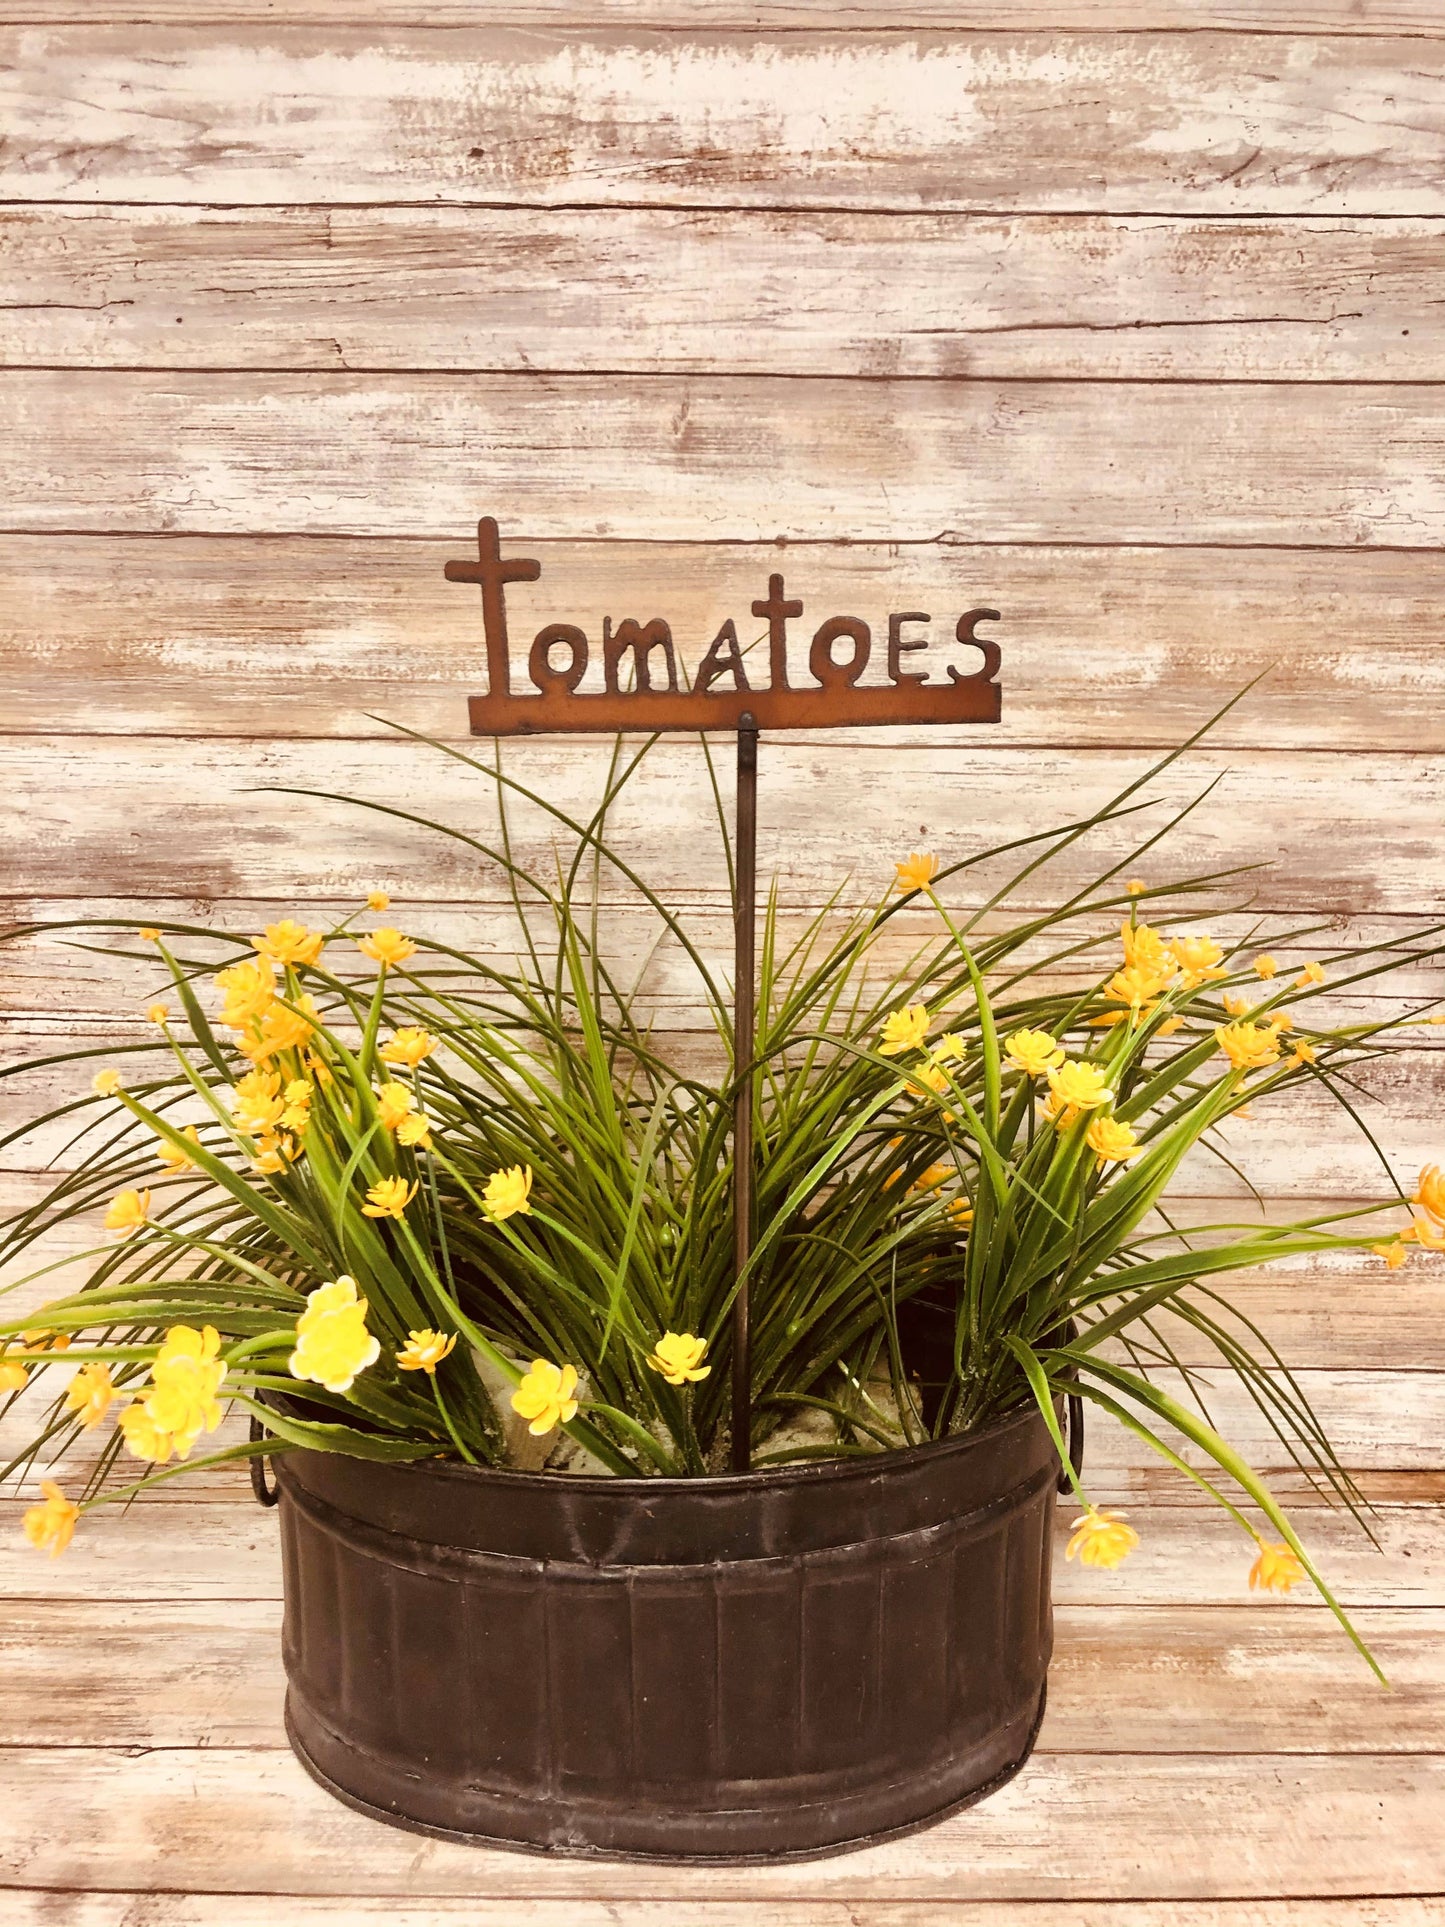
[0,25,1445,216]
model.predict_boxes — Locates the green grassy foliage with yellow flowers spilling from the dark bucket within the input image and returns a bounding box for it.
[0,738,1445,1663]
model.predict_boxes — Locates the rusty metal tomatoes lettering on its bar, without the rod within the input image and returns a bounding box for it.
[447,516,1000,736]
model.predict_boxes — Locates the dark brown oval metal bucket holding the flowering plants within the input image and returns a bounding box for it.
[276,1409,1058,1861]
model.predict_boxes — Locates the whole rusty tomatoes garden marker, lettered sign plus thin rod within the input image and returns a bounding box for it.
[445,515,1002,1472]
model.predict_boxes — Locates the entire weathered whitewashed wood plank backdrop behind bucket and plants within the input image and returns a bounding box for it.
[0,0,1445,1927]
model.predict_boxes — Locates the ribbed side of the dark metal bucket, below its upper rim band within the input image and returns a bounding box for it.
[279,1418,1054,1860]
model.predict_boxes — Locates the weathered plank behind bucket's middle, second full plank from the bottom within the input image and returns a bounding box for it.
[0,1599,1445,1769]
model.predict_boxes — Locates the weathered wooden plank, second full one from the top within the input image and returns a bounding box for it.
[0,204,1445,382]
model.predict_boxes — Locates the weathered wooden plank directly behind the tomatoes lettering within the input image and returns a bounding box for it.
[0,543,1445,757]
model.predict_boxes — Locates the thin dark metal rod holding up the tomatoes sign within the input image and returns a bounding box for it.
[732,711,757,1472]
